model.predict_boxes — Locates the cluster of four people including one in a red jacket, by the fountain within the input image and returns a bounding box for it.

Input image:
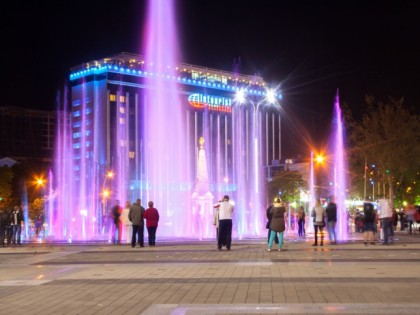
[111,199,159,248]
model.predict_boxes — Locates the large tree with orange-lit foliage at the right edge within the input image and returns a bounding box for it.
[346,96,420,203]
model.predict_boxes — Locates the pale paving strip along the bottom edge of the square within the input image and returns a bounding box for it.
[142,303,420,315]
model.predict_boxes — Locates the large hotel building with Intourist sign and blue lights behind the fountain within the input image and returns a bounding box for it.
[61,53,281,239]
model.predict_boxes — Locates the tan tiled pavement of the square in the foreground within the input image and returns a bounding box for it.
[0,234,420,314]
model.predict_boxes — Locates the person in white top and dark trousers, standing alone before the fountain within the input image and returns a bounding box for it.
[214,195,233,250]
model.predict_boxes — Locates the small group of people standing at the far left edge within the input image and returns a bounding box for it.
[0,206,23,247]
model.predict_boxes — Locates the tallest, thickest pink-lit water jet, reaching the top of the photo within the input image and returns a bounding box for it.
[142,0,189,237]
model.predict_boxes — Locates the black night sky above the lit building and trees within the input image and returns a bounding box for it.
[0,0,420,155]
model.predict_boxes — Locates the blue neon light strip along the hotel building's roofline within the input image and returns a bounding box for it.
[70,65,283,100]
